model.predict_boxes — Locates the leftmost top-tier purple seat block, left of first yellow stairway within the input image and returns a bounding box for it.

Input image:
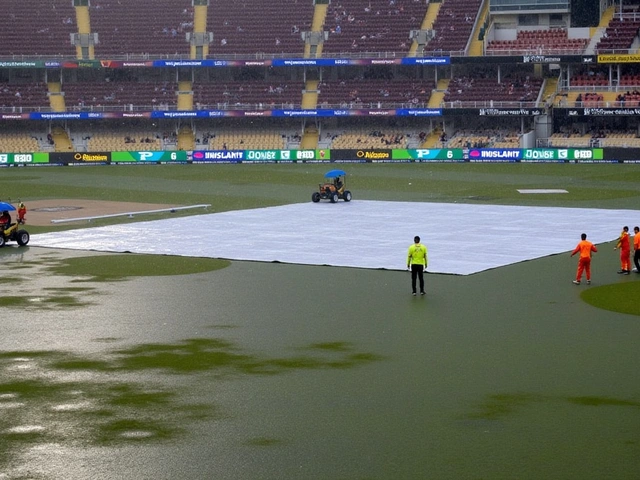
[0,0,78,58]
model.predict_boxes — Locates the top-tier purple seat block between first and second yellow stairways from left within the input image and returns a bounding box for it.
[89,0,193,58]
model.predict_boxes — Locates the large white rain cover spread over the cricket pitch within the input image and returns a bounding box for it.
[30,201,640,275]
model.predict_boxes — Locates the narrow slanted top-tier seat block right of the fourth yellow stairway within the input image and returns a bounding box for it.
[424,0,482,54]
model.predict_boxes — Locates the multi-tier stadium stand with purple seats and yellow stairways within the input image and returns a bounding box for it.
[0,0,640,152]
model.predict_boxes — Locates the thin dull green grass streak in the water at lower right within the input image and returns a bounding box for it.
[462,393,640,420]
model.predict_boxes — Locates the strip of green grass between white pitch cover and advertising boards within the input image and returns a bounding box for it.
[0,163,640,233]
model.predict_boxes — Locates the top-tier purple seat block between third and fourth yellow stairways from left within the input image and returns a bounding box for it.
[323,0,426,55]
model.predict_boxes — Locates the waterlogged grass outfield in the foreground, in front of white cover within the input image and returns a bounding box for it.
[0,245,640,480]
